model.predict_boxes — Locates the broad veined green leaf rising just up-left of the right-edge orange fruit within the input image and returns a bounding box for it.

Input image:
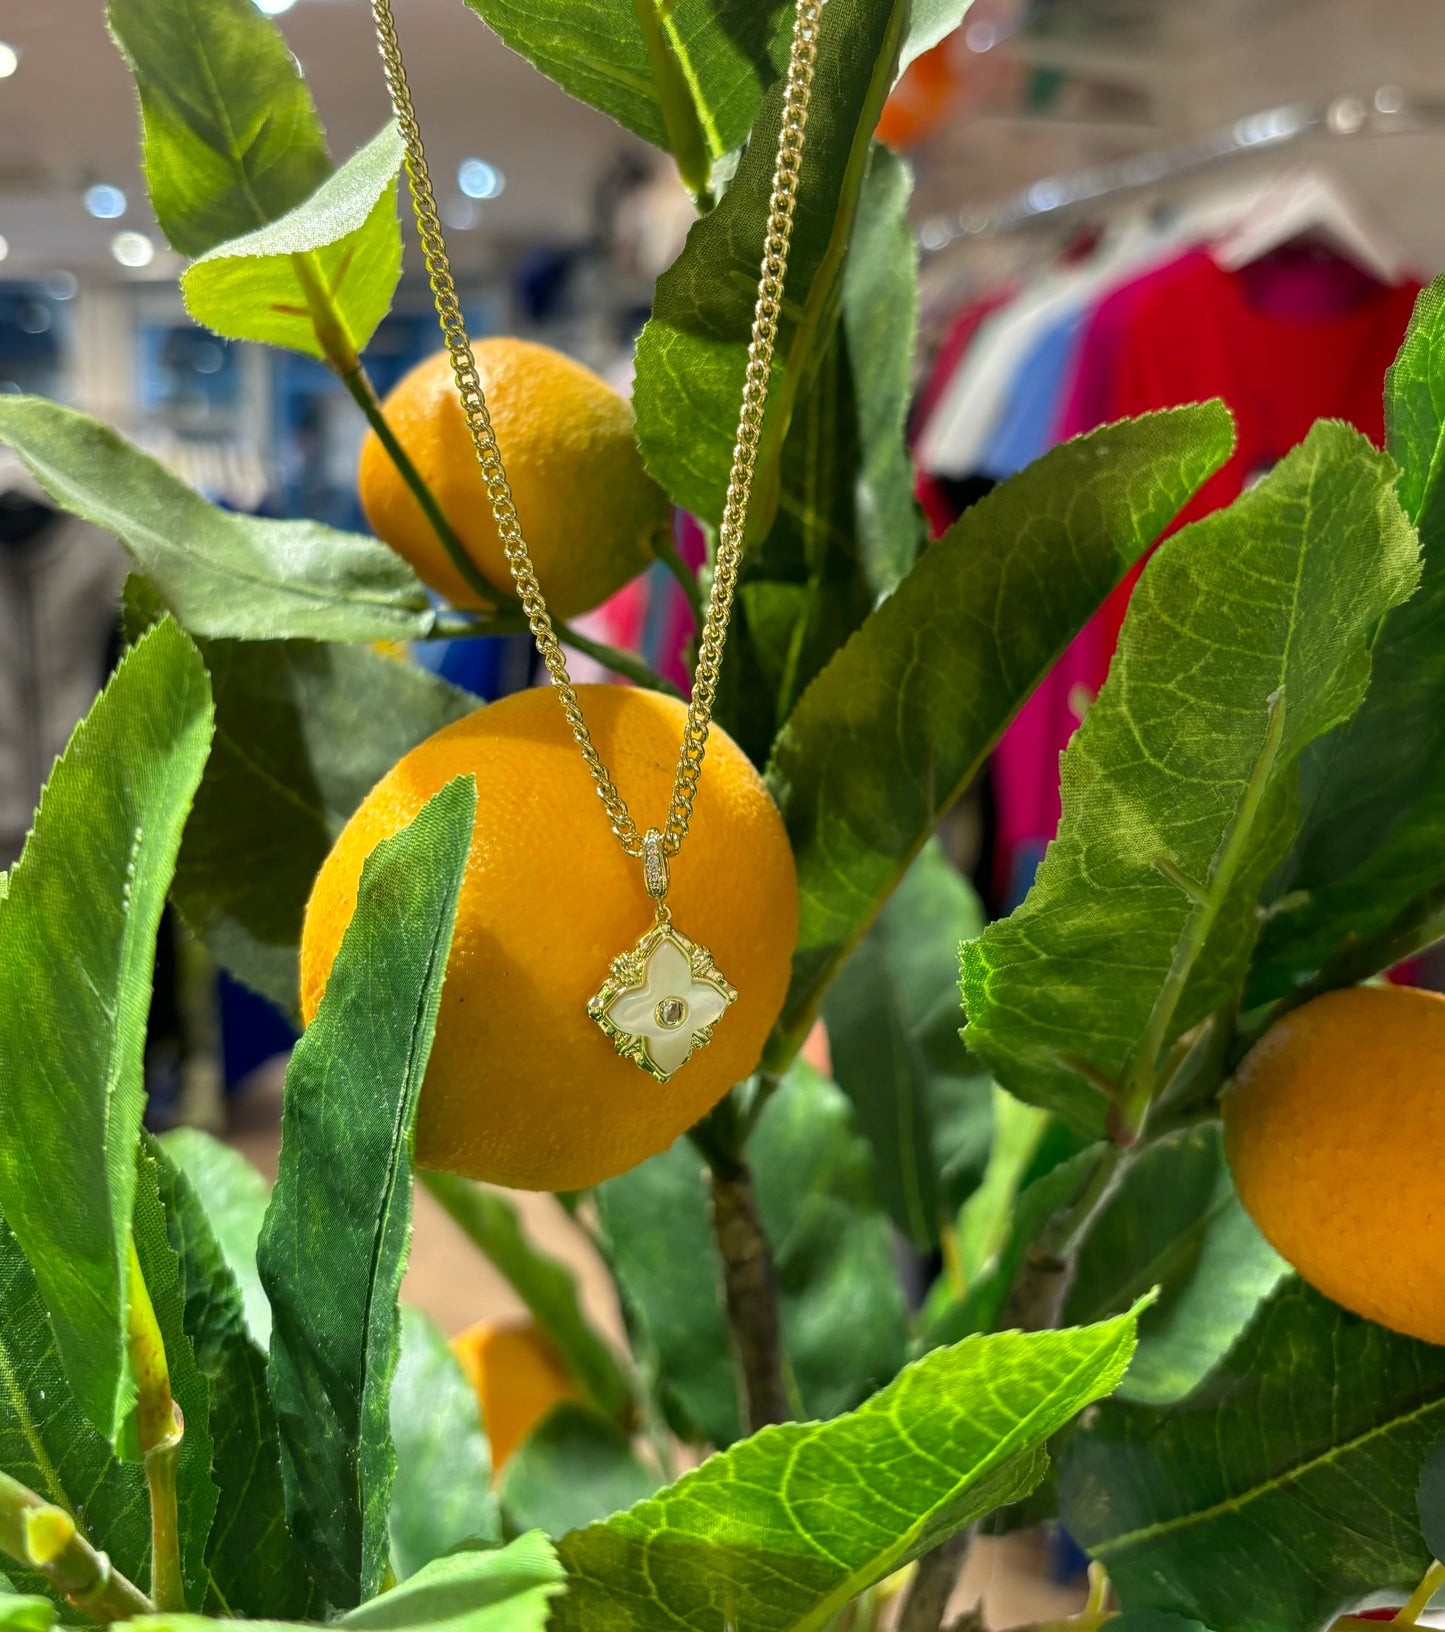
[963,421,1419,1133]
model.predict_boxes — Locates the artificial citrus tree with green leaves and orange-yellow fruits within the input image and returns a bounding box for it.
[0,0,1445,1632]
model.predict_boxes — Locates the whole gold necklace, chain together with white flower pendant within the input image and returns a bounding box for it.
[371,0,825,1082]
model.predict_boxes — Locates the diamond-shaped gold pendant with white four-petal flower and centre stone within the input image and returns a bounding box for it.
[588,922,738,1082]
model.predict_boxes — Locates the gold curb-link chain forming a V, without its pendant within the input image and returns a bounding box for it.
[371,0,825,857]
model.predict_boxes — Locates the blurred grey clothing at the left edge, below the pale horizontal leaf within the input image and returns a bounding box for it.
[0,447,126,870]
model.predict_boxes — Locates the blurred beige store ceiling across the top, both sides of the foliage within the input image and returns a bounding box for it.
[0,0,1445,279]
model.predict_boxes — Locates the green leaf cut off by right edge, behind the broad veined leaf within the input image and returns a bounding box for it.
[1251,277,1445,1002]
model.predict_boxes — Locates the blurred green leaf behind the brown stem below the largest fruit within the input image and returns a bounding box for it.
[596,1062,905,1444]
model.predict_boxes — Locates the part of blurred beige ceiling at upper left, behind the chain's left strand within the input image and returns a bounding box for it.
[0,0,643,276]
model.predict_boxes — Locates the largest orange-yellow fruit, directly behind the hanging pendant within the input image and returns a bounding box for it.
[300,685,798,1190]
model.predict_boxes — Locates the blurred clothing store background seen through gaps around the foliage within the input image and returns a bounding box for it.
[0,0,1445,1605]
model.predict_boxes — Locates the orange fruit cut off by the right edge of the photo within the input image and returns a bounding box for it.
[1225,986,1445,1343]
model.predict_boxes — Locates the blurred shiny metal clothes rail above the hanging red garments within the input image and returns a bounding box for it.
[918,85,1445,255]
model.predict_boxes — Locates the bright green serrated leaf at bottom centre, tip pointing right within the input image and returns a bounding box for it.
[552,1315,1135,1632]
